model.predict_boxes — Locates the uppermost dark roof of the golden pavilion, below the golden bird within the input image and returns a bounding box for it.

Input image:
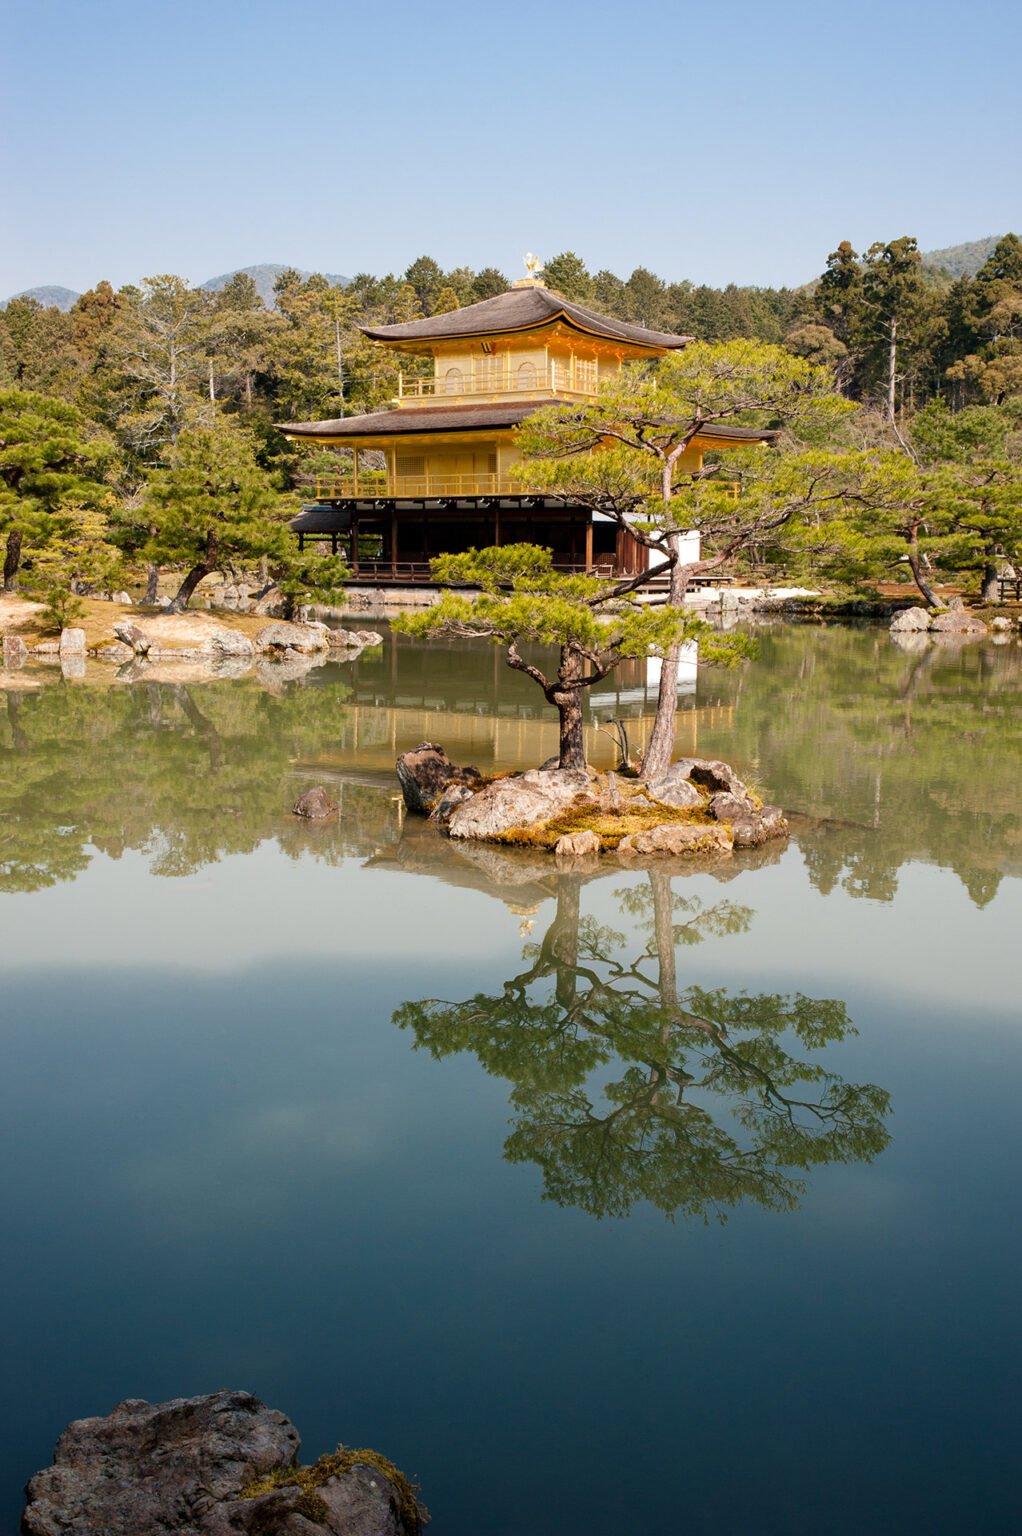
[361,287,692,352]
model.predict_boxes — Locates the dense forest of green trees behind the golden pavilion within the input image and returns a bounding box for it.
[0,235,1022,611]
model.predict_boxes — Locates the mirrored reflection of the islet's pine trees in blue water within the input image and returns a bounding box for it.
[395,869,890,1220]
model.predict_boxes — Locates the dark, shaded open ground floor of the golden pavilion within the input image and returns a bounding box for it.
[290,496,649,585]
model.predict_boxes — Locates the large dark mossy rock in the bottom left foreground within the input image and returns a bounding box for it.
[22,1392,426,1536]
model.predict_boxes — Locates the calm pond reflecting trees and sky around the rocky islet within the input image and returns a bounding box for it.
[0,628,1022,1536]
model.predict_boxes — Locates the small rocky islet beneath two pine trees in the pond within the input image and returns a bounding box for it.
[397,742,788,859]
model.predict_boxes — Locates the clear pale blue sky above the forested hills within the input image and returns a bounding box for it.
[0,0,1022,295]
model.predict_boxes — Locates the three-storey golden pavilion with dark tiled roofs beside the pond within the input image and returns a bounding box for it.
[281,267,762,584]
